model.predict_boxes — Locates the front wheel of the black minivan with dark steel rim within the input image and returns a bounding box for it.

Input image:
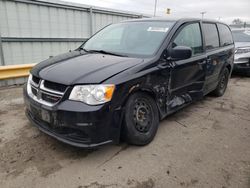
[122,92,159,146]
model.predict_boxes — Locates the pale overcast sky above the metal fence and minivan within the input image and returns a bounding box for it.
[60,0,250,23]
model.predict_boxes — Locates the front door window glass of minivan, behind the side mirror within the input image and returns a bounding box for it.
[172,23,203,55]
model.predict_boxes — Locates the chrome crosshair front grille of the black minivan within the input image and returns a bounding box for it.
[29,76,67,106]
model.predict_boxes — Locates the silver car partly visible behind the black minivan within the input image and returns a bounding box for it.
[232,29,250,76]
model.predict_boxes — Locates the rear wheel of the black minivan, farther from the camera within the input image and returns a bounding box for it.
[212,68,230,97]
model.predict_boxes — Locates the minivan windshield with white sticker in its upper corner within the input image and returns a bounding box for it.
[82,21,174,56]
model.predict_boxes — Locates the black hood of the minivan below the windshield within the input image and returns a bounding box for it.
[31,51,143,85]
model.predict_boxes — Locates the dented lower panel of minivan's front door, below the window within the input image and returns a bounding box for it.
[167,55,206,113]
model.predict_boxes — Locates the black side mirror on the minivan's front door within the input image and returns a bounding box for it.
[169,46,192,61]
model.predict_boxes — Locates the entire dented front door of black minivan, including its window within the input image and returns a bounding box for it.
[167,21,206,112]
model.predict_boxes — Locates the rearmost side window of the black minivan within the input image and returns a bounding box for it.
[218,24,233,46]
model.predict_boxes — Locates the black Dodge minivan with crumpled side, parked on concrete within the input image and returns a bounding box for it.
[24,19,234,148]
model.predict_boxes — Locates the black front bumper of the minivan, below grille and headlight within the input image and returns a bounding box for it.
[24,86,122,148]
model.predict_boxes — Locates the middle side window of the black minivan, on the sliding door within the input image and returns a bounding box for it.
[203,23,220,50]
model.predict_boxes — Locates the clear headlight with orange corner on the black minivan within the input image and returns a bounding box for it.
[69,84,115,105]
